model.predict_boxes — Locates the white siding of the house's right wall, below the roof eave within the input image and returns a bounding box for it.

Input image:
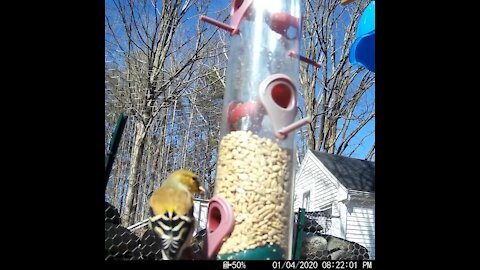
[345,201,375,259]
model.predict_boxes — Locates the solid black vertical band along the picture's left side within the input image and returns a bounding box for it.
[10,1,105,265]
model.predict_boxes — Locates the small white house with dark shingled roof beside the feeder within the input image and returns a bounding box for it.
[294,150,375,259]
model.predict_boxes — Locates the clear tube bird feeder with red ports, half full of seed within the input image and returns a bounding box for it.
[201,0,312,260]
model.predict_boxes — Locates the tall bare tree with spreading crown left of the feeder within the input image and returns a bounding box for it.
[105,0,220,225]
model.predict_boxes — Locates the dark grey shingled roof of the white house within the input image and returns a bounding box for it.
[310,150,375,192]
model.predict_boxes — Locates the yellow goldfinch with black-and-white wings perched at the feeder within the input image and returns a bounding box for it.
[148,170,204,260]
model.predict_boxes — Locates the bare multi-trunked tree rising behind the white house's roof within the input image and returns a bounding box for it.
[298,0,375,158]
